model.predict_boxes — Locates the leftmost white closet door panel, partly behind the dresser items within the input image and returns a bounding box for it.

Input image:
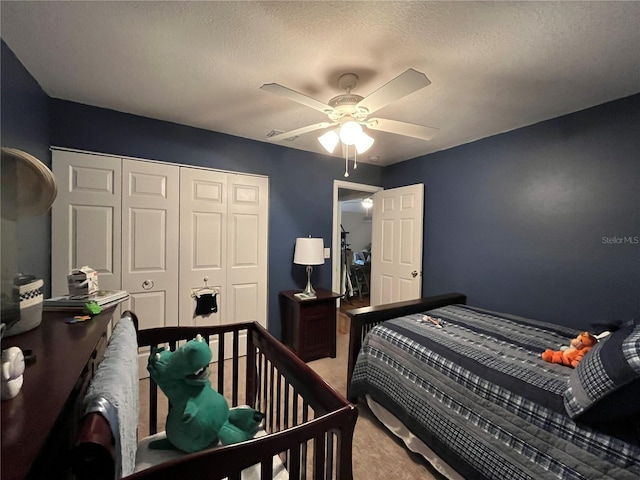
[51,150,122,296]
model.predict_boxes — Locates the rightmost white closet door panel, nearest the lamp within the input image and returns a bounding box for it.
[223,174,269,327]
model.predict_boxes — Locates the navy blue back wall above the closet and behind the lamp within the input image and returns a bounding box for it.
[50,99,382,336]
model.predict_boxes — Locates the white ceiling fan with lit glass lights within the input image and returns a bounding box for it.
[260,68,438,172]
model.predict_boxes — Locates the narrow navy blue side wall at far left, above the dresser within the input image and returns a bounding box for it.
[0,40,51,295]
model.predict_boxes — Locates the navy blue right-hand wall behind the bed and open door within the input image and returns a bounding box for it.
[384,95,640,328]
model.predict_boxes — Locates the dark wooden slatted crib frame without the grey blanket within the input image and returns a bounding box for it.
[73,312,358,480]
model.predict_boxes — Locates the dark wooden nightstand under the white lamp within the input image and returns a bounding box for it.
[279,288,340,362]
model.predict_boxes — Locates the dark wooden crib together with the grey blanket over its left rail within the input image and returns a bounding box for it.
[73,312,357,480]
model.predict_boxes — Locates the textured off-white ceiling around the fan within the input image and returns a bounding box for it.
[0,1,640,165]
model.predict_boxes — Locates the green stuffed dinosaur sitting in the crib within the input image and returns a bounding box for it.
[147,335,264,453]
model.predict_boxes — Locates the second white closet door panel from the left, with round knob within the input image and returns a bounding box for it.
[122,160,180,329]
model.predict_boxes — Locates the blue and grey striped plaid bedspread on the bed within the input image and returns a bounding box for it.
[351,305,640,480]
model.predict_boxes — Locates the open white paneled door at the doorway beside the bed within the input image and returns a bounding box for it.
[370,184,424,306]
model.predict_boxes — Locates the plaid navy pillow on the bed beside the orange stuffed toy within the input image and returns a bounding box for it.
[564,324,640,424]
